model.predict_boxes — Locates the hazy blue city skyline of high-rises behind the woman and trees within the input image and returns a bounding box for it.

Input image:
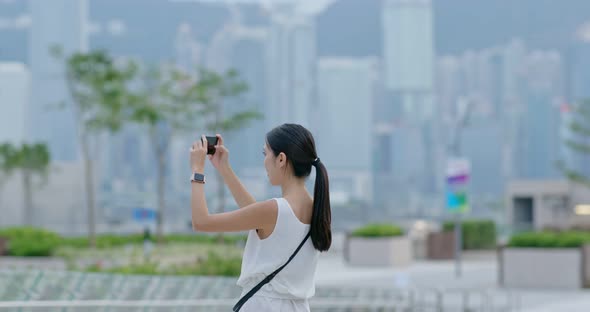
[0,0,590,232]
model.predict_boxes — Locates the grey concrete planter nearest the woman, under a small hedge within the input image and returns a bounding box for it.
[346,236,413,267]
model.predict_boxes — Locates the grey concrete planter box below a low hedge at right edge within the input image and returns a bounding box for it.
[498,245,590,289]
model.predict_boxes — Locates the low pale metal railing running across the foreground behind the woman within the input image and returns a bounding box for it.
[0,270,520,312]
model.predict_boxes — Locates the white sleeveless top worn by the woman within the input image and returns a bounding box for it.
[237,198,319,299]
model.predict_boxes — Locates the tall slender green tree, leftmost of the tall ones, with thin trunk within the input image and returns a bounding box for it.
[53,48,137,247]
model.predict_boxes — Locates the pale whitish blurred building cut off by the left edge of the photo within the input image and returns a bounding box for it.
[0,63,31,144]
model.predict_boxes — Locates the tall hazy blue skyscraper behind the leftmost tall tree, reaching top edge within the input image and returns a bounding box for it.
[27,0,88,161]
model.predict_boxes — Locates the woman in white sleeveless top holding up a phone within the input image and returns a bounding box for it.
[191,124,332,312]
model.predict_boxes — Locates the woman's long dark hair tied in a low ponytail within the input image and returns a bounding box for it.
[266,124,332,251]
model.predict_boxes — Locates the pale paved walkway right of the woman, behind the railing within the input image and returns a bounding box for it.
[316,253,590,312]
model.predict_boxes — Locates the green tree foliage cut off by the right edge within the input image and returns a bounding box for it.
[557,99,590,187]
